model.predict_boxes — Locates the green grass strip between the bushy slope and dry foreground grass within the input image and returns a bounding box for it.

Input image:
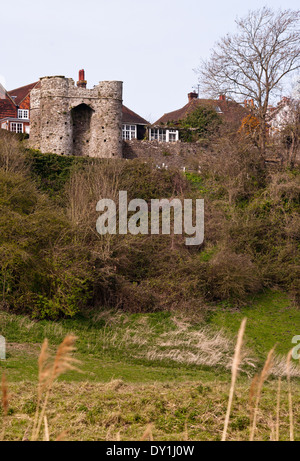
[0,292,300,383]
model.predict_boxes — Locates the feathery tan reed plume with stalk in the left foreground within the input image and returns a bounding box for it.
[31,335,80,441]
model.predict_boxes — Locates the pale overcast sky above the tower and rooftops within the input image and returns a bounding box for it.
[0,0,299,122]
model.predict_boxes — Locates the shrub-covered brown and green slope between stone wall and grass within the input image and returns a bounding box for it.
[0,127,300,318]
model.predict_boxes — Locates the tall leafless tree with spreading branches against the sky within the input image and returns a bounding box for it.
[196,7,300,154]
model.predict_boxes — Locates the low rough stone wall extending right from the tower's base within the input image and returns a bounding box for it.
[123,140,215,171]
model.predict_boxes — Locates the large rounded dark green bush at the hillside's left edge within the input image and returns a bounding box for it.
[0,172,90,318]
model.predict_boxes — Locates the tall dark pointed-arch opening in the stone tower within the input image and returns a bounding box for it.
[71,104,94,156]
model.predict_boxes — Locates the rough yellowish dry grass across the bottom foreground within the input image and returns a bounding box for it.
[0,379,300,441]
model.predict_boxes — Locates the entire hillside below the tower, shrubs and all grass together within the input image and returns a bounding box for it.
[0,127,300,440]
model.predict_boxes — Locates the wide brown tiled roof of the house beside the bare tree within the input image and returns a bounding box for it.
[154,98,249,125]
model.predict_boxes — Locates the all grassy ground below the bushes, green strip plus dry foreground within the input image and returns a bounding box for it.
[0,293,300,440]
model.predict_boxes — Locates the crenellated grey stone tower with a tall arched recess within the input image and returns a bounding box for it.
[29,70,122,158]
